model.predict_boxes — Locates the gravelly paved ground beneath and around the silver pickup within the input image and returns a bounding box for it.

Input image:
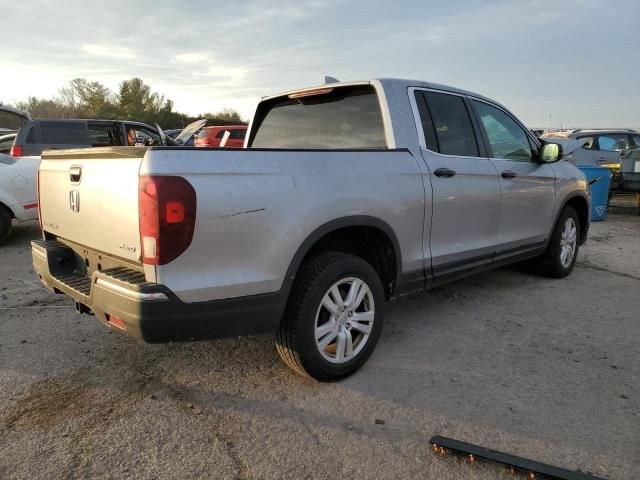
[0,215,640,480]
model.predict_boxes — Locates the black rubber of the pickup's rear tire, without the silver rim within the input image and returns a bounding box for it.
[276,252,385,381]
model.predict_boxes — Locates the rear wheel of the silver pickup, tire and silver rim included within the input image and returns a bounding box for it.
[276,252,384,381]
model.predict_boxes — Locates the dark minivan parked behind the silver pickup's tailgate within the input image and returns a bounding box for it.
[11,119,162,157]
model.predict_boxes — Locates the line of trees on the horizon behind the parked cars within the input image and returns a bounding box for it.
[16,78,247,129]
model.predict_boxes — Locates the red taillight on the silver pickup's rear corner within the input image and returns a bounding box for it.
[138,176,196,265]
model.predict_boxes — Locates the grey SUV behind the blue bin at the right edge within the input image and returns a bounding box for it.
[542,129,640,171]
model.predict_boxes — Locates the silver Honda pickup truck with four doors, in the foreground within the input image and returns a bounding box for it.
[32,79,590,380]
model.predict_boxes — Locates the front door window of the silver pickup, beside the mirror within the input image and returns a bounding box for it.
[471,100,533,162]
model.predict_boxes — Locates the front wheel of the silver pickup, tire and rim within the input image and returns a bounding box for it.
[536,206,580,278]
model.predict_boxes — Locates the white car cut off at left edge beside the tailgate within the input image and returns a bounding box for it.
[0,154,40,244]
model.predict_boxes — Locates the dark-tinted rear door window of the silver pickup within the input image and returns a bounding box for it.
[424,92,480,157]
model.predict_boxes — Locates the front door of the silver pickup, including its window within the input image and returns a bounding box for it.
[470,99,556,255]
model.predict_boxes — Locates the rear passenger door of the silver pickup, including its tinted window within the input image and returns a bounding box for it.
[412,89,500,283]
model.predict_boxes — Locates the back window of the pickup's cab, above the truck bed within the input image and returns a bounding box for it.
[249,85,387,149]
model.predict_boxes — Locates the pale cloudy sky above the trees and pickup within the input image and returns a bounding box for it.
[0,0,640,127]
